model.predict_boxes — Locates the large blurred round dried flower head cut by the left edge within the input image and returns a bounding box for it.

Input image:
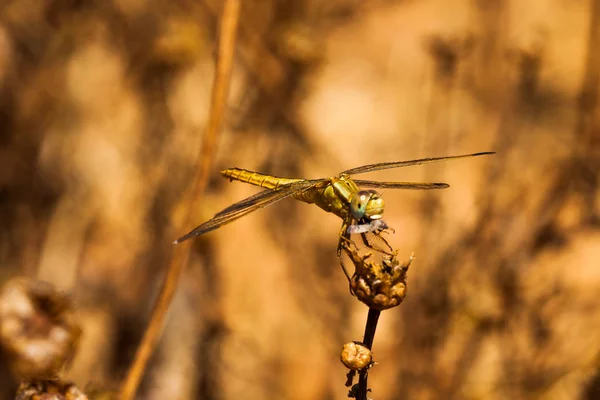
[0,278,81,381]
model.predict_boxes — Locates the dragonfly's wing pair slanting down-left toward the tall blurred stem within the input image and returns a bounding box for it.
[173,181,315,244]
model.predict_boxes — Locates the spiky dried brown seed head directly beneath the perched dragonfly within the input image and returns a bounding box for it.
[342,238,414,311]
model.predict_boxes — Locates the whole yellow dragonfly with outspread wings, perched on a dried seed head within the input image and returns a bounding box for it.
[174,152,494,242]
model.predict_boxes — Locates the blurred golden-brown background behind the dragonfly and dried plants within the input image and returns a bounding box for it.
[0,0,600,399]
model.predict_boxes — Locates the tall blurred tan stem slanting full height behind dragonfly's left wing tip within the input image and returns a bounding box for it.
[120,0,240,400]
